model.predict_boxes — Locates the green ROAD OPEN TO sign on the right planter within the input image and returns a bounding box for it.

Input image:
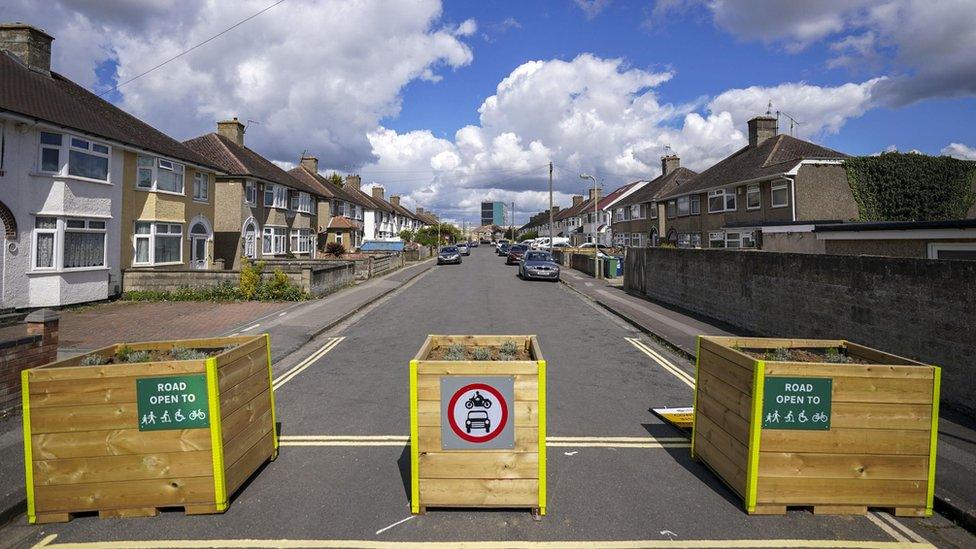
[763,377,832,431]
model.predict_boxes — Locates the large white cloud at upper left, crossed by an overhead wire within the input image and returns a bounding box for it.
[2,0,477,166]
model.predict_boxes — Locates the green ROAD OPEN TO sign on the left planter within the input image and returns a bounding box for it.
[136,374,210,431]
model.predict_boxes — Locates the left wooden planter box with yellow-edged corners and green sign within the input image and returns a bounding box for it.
[22,335,278,523]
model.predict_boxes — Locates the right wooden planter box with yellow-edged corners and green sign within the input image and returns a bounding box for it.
[692,336,941,516]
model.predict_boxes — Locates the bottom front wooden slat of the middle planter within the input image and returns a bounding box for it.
[420,478,539,507]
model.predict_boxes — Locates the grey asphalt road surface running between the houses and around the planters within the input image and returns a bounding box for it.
[0,246,976,548]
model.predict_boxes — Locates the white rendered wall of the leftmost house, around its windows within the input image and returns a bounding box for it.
[0,115,124,310]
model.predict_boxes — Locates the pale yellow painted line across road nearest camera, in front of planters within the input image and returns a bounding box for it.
[28,534,934,549]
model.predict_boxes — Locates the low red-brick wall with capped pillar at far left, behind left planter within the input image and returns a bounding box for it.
[0,309,59,418]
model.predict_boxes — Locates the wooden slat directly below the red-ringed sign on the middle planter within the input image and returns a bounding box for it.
[420,451,539,479]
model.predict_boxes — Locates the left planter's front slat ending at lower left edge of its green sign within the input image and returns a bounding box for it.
[31,402,139,434]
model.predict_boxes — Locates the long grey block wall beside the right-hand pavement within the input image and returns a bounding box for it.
[624,248,976,417]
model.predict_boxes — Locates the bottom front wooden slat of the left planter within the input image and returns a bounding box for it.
[34,477,214,512]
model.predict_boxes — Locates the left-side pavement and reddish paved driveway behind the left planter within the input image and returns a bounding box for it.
[0,260,433,532]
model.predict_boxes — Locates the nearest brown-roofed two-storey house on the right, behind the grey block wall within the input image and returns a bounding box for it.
[659,115,858,248]
